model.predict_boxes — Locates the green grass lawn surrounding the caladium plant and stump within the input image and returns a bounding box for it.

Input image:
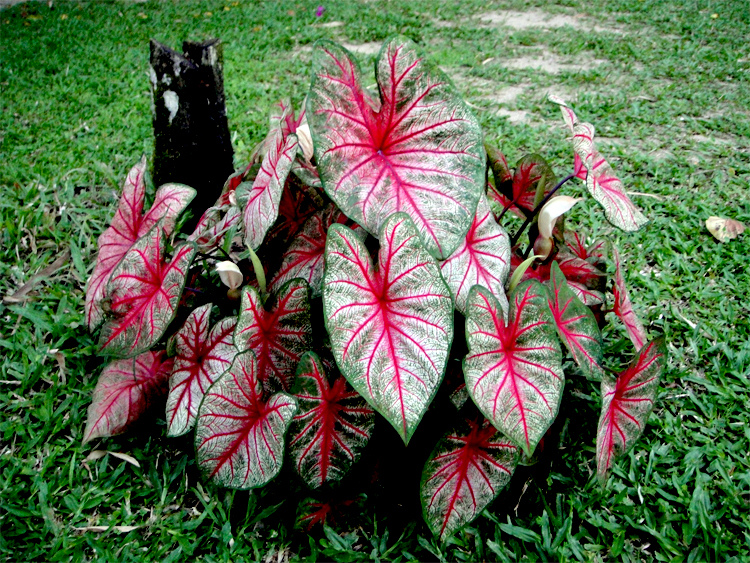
[0,0,750,561]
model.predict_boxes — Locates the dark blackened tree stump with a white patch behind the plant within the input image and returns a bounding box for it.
[151,39,234,228]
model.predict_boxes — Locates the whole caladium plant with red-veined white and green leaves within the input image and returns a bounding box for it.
[83,37,666,541]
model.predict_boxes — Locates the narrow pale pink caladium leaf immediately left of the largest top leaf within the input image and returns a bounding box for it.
[242,124,297,249]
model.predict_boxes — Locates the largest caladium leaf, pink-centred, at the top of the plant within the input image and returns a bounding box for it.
[307,38,486,259]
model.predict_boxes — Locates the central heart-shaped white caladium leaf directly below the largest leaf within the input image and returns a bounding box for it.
[323,213,453,443]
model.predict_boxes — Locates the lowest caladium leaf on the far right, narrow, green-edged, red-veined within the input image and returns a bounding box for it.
[596,340,666,483]
